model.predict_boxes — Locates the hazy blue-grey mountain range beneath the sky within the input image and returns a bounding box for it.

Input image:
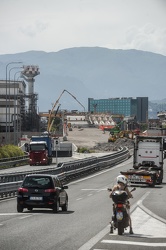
[0,47,166,116]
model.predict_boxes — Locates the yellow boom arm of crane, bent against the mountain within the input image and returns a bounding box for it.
[47,89,85,132]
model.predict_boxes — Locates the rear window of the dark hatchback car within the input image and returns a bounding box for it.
[23,176,53,189]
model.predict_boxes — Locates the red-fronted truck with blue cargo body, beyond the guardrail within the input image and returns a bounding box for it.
[29,135,52,166]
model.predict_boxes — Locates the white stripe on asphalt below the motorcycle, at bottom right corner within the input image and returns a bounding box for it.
[101,240,166,247]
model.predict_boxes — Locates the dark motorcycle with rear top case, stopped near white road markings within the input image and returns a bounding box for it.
[108,188,136,235]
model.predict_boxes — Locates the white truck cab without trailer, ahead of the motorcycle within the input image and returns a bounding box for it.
[121,135,164,187]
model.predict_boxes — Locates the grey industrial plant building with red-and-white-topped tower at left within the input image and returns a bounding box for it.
[0,65,40,144]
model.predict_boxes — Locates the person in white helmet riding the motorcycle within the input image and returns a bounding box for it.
[109,175,133,234]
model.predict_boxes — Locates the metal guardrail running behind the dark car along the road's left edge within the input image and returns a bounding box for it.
[0,147,130,199]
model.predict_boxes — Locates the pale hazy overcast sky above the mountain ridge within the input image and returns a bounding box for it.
[0,0,166,55]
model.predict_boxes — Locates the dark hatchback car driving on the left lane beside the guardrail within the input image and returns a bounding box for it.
[17,174,68,213]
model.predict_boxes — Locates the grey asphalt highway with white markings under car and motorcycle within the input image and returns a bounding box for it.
[0,158,166,250]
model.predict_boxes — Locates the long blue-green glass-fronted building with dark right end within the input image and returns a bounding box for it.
[88,97,148,122]
